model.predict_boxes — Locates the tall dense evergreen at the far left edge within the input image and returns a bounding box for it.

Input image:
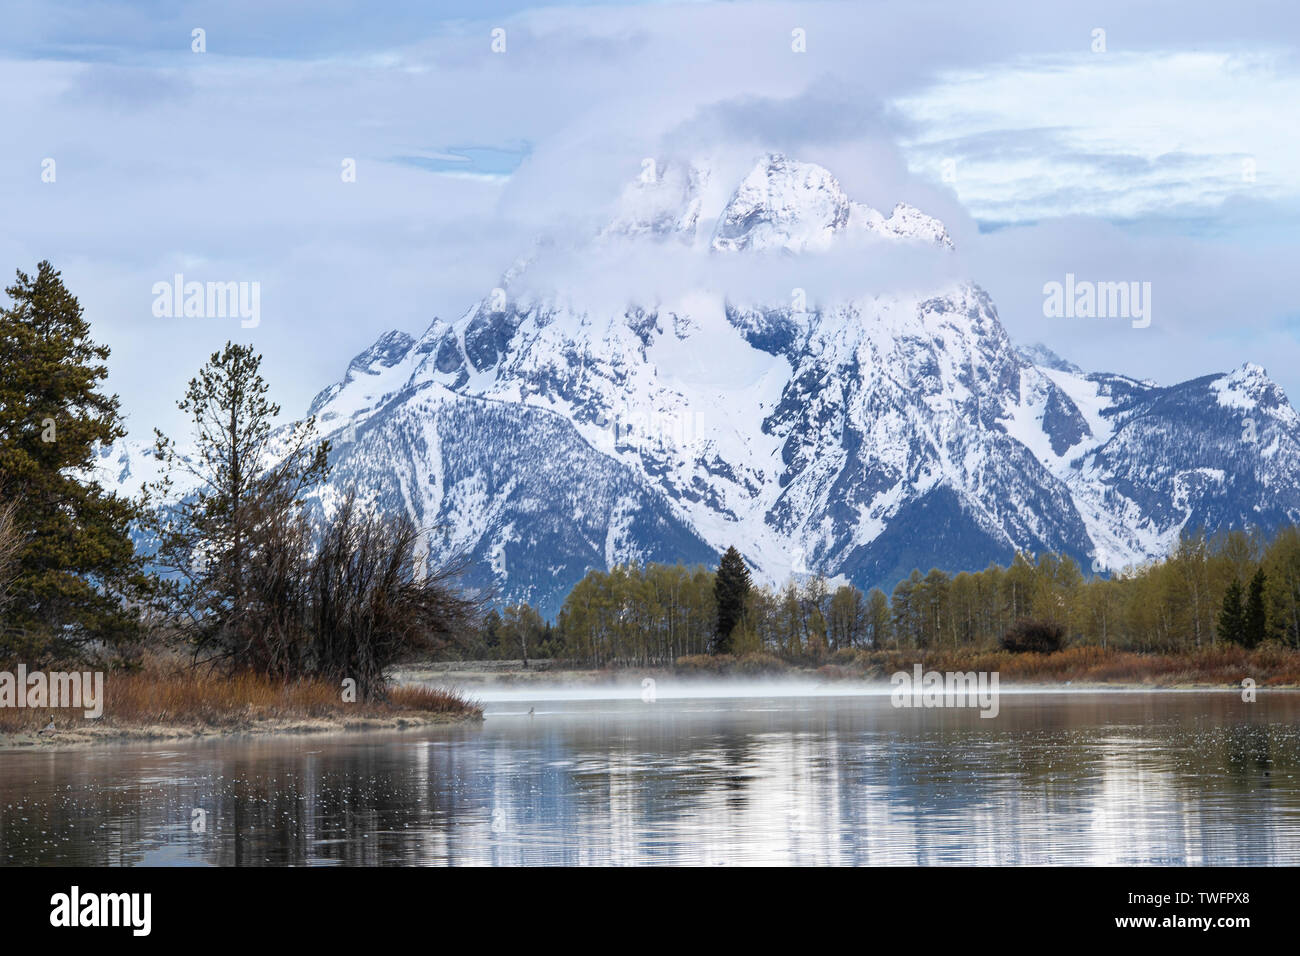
[0,261,150,658]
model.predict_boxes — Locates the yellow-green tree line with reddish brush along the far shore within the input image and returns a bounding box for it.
[450,504,1300,685]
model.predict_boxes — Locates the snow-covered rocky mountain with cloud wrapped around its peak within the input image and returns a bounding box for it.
[111,155,1300,613]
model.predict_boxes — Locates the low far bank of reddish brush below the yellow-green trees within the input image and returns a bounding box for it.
[395,646,1300,688]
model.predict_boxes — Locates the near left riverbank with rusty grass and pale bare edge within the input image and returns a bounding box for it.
[0,672,482,750]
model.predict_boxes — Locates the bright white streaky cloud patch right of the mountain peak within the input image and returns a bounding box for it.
[896,51,1300,222]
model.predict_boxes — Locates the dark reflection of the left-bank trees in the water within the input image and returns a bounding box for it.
[0,748,467,866]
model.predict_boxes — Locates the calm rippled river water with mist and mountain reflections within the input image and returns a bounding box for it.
[0,687,1300,866]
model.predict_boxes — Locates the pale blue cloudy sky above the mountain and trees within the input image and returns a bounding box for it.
[0,0,1300,437]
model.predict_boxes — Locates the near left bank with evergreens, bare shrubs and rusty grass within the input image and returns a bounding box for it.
[0,261,482,748]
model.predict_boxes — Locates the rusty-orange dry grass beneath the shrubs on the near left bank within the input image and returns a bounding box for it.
[0,669,482,734]
